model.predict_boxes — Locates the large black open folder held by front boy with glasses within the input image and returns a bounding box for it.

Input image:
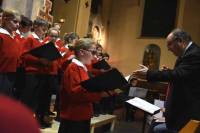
[81,69,128,92]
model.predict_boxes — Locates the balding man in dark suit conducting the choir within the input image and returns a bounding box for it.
[133,29,200,133]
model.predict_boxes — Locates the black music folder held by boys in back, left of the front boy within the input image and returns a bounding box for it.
[29,42,62,61]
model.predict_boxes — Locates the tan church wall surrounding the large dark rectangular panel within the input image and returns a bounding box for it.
[106,0,200,75]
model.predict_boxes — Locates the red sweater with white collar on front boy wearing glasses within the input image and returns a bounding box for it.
[60,59,101,121]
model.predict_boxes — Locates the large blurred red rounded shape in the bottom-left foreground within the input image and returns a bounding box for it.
[0,96,40,133]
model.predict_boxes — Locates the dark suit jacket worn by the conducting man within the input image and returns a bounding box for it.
[147,43,200,130]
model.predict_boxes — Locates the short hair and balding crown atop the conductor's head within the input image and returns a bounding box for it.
[171,29,192,44]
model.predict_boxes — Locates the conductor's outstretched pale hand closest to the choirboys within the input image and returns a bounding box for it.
[132,64,149,79]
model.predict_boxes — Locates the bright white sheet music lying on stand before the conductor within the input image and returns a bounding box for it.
[126,97,160,114]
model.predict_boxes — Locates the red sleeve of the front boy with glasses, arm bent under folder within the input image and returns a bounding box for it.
[64,67,101,103]
